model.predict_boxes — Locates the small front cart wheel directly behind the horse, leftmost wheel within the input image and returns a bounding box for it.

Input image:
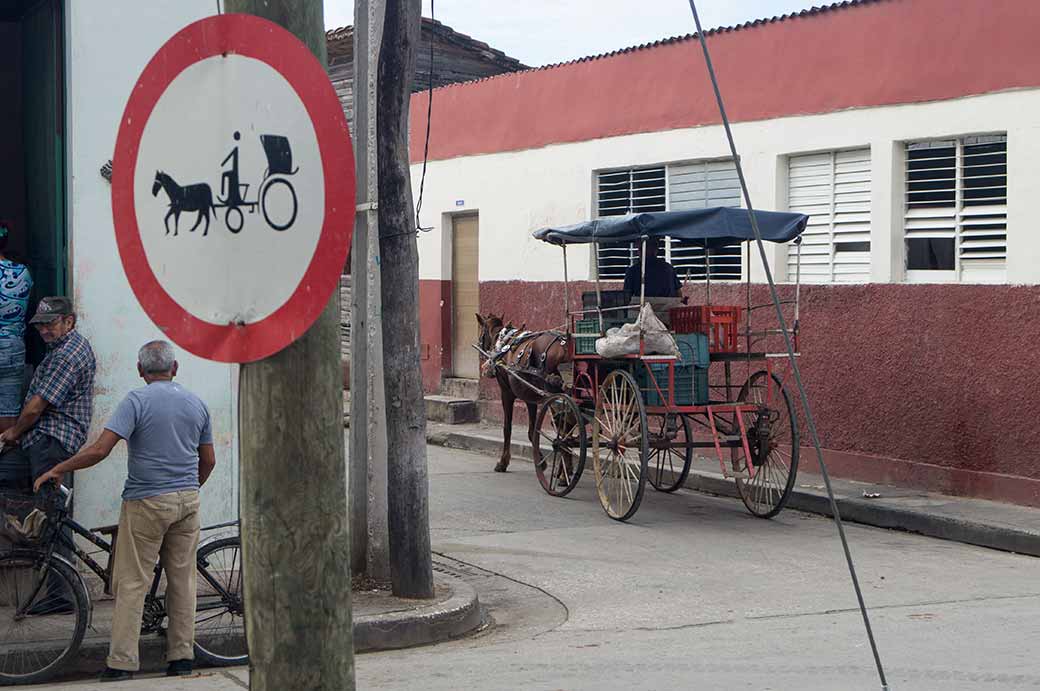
[535,393,587,496]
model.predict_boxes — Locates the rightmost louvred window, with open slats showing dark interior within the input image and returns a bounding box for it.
[904,134,1008,282]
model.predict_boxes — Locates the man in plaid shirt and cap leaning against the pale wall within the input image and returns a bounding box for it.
[0,297,96,492]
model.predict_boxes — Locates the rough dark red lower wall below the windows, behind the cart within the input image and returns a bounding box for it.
[480,282,1040,506]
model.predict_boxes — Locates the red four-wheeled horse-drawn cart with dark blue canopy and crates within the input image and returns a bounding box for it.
[524,208,807,520]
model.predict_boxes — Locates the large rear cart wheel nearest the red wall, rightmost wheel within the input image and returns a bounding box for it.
[733,370,800,518]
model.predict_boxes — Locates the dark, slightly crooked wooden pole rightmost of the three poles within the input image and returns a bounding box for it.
[376,0,434,597]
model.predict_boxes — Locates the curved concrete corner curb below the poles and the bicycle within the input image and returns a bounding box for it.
[56,571,484,684]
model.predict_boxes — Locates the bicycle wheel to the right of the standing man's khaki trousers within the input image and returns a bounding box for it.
[194,537,250,666]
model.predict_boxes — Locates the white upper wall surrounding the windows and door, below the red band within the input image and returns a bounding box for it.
[412,85,1040,283]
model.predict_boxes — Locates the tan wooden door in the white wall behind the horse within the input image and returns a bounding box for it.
[451,215,480,379]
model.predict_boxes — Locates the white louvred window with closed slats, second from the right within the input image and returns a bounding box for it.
[787,149,870,283]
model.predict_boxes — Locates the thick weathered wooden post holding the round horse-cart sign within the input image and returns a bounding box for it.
[225,0,355,691]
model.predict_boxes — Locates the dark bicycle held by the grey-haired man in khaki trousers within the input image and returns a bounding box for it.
[0,486,249,686]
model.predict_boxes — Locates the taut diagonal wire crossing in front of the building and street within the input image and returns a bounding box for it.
[688,0,888,691]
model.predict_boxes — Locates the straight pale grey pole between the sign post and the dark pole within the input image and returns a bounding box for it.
[349,0,390,582]
